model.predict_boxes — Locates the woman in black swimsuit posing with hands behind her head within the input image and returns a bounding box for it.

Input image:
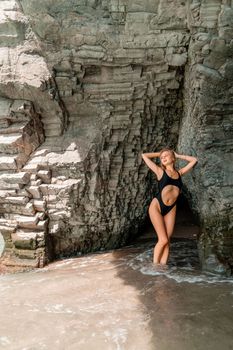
[142,148,197,265]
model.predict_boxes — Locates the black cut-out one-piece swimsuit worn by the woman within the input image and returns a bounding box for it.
[156,170,182,216]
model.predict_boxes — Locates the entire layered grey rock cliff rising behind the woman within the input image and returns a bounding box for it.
[0,0,233,274]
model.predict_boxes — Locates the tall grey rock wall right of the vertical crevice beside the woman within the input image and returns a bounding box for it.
[179,1,233,274]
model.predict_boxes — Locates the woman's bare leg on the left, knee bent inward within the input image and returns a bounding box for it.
[149,198,168,264]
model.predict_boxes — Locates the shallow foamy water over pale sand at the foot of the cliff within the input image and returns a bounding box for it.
[0,227,233,350]
